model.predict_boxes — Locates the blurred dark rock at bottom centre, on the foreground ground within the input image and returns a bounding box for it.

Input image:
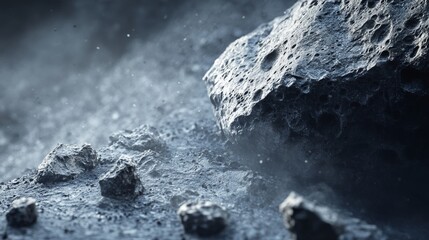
[177,201,228,236]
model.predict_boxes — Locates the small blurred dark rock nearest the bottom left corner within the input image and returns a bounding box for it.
[6,197,37,227]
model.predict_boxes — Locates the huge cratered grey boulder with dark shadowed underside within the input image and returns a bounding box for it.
[204,0,429,157]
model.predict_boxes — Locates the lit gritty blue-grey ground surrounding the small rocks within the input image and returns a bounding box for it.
[0,122,292,239]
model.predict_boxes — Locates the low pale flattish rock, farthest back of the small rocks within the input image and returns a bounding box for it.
[109,125,167,152]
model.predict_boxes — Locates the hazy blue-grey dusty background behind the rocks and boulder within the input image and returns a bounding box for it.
[0,0,294,181]
